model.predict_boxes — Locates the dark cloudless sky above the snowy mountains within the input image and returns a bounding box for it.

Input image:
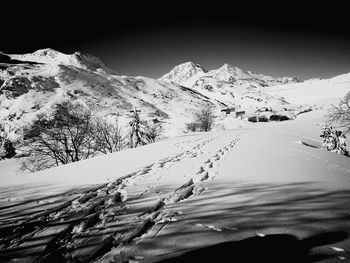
[0,1,350,79]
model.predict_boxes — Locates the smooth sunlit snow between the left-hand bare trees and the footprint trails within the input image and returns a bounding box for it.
[0,133,221,186]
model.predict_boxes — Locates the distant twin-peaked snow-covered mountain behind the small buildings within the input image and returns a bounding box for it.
[159,62,302,111]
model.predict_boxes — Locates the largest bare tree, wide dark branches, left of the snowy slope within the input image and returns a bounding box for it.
[20,102,96,171]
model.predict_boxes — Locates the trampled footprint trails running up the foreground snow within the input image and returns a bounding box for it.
[0,135,243,261]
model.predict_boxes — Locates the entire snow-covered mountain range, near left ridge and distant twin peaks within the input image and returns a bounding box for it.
[0,49,350,140]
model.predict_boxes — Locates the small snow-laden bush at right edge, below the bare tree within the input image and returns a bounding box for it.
[320,125,349,156]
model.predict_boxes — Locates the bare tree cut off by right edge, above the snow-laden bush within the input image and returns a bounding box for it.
[328,92,350,133]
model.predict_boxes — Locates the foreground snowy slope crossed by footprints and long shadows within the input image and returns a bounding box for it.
[0,112,350,263]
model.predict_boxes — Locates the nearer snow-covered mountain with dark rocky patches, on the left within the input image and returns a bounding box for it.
[0,49,226,140]
